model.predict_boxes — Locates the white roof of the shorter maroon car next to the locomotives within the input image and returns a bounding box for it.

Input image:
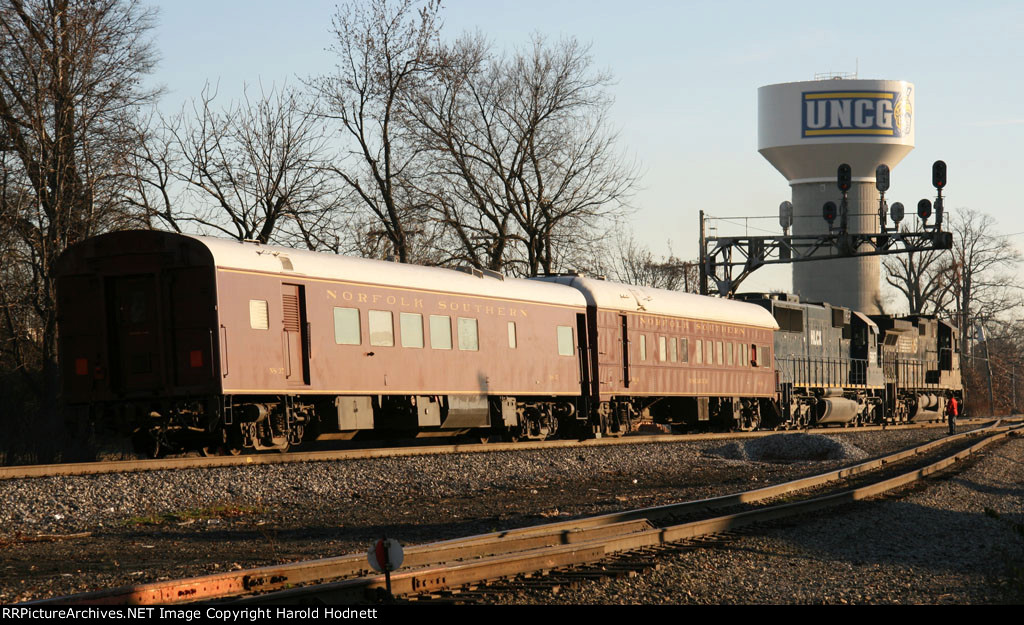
[537,276,778,330]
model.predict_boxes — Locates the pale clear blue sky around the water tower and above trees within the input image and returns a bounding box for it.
[146,0,1024,297]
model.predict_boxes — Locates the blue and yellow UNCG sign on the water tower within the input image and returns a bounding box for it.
[803,89,912,137]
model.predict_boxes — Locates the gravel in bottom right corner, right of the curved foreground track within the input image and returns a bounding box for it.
[503,432,1024,605]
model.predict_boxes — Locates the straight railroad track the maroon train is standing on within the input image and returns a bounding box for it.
[0,418,992,480]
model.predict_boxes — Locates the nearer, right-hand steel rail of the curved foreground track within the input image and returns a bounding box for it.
[239,425,1024,605]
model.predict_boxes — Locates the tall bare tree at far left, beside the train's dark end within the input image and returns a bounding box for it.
[0,0,156,459]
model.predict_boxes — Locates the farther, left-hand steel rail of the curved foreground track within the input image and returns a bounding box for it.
[25,423,1009,605]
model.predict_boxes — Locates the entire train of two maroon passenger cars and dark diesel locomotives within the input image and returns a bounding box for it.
[55,231,962,454]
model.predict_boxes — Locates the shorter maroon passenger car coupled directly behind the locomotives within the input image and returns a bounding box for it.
[542,276,778,431]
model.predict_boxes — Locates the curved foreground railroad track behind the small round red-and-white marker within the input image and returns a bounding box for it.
[28,423,1024,605]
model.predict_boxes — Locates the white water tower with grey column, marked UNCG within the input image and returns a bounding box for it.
[758,79,914,314]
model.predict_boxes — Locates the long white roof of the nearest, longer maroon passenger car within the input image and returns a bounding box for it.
[189,231,587,308]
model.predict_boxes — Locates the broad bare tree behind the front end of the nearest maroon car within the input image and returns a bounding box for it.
[409,36,637,276]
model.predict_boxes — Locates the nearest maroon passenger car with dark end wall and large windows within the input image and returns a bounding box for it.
[56,227,590,451]
